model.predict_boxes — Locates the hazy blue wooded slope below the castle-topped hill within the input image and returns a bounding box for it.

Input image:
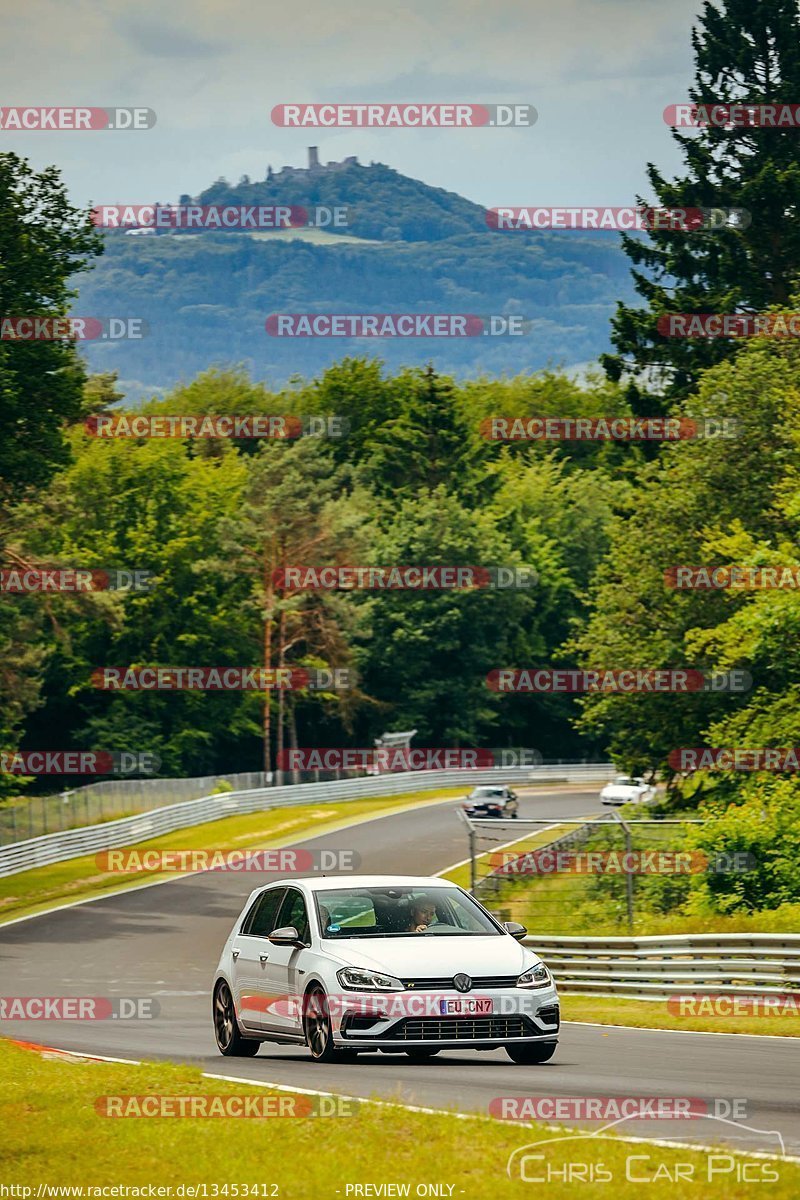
[76,223,633,402]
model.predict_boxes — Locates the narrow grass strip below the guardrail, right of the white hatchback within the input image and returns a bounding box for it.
[561,992,800,1038]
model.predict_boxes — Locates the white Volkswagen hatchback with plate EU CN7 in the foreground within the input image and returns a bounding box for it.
[212,875,559,1063]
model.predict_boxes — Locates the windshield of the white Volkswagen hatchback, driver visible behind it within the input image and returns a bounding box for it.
[314,884,503,941]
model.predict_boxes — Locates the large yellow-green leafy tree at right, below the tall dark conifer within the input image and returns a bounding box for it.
[572,333,800,773]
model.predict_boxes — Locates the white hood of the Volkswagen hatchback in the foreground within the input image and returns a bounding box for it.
[330,934,539,979]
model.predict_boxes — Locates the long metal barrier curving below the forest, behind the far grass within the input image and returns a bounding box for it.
[0,763,615,876]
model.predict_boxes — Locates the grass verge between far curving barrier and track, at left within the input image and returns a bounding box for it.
[0,788,463,924]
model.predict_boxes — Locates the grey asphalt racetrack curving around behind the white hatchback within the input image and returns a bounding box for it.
[0,786,800,1154]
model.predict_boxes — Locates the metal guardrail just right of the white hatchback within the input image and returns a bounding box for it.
[525,934,800,1001]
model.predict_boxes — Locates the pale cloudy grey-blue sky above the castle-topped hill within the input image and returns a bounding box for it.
[0,0,700,208]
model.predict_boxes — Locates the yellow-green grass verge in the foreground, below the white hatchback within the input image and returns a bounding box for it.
[0,1040,800,1200]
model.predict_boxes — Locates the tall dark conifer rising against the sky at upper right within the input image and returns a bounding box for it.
[603,0,800,414]
